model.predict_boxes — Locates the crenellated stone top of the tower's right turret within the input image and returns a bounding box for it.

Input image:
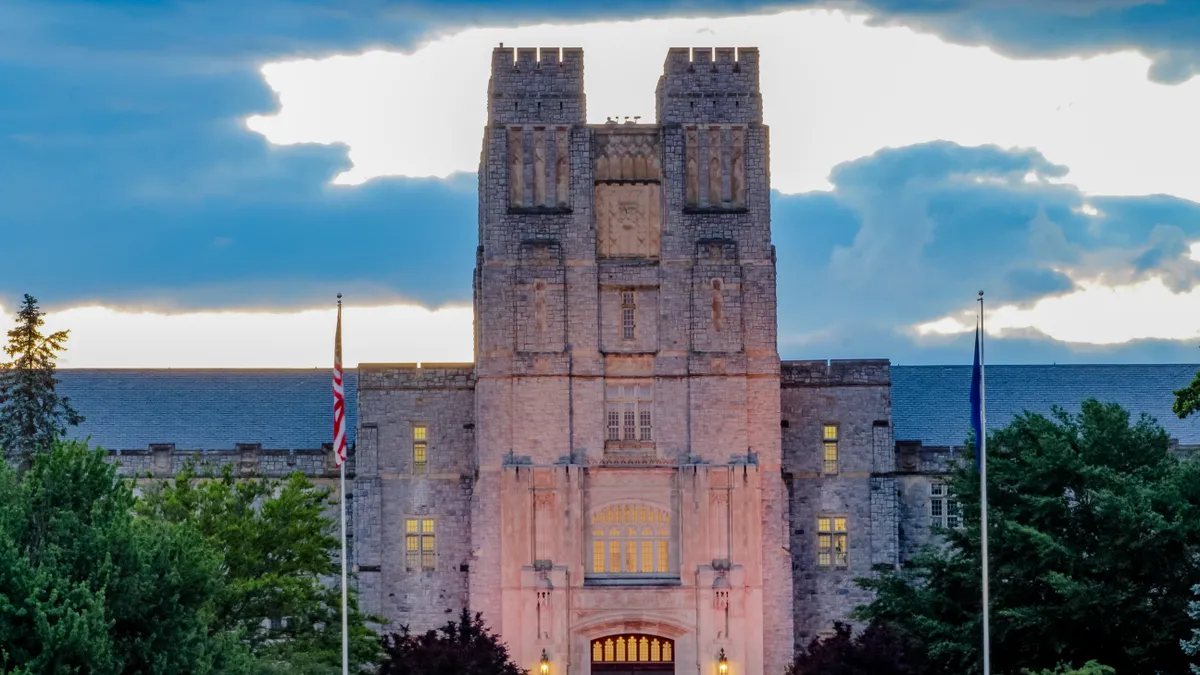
[656,47,762,124]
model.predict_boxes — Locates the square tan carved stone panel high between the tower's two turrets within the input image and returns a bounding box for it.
[595,183,662,258]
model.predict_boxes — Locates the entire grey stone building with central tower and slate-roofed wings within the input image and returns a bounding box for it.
[54,47,1200,675]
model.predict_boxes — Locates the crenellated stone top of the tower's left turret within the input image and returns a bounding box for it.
[487,46,587,125]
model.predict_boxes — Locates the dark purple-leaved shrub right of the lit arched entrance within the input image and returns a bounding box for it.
[786,621,925,675]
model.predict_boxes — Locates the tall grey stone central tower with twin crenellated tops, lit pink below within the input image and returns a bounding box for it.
[468,47,792,674]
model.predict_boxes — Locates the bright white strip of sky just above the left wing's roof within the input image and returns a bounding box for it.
[0,305,474,368]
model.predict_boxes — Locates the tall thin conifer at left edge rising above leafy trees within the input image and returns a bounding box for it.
[0,294,84,458]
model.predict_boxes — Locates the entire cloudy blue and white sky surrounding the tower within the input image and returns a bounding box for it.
[0,0,1200,368]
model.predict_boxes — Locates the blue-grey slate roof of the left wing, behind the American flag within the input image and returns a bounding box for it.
[59,369,359,450]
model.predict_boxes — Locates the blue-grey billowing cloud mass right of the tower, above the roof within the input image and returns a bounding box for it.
[773,142,1200,363]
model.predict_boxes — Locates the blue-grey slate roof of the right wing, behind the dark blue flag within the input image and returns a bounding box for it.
[892,364,1200,446]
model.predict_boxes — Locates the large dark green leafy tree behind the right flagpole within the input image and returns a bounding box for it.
[856,400,1200,674]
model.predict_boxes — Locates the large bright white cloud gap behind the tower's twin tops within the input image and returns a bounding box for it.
[246,10,1200,201]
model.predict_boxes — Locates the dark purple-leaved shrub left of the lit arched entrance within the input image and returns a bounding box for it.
[378,609,528,675]
